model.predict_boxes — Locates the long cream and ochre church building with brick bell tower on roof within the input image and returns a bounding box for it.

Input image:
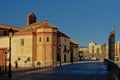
[0,13,78,67]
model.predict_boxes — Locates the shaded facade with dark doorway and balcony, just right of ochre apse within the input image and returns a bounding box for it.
[58,31,70,62]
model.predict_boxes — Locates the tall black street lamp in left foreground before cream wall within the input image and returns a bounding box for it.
[8,28,14,77]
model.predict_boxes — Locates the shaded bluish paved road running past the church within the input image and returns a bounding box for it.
[0,61,112,80]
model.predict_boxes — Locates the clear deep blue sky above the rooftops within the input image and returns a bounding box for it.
[0,0,120,46]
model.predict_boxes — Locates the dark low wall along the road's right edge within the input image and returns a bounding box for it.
[104,59,120,80]
